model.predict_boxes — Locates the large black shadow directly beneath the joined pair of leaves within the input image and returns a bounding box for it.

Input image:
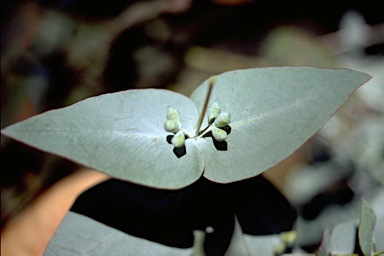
[71,175,296,254]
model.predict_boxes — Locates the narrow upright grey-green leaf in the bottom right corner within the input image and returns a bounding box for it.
[358,199,376,256]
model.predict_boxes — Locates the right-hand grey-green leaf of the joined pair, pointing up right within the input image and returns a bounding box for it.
[191,67,370,183]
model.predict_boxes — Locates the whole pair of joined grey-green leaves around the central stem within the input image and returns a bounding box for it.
[2,67,370,188]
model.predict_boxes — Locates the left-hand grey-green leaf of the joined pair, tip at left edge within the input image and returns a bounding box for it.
[2,89,203,188]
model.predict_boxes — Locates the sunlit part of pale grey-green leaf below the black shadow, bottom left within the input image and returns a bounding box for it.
[44,212,192,256]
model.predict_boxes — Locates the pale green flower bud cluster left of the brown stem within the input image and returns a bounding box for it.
[164,107,185,148]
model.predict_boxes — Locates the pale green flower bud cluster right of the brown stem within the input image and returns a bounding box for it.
[207,101,231,142]
